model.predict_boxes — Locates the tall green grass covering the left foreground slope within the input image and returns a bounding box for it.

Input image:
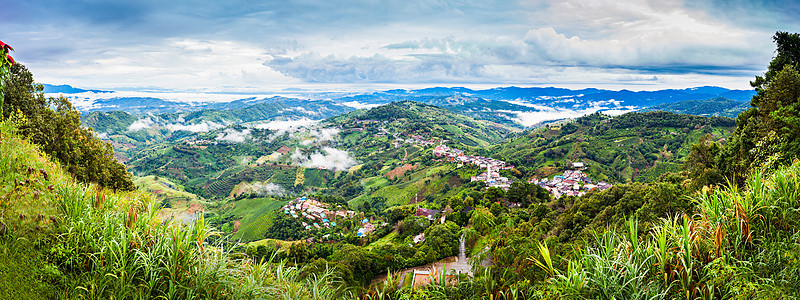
[0,122,353,299]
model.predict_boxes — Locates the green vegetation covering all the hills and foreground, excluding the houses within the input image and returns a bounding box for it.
[0,32,800,299]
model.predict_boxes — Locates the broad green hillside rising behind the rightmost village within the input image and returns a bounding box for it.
[490,112,736,182]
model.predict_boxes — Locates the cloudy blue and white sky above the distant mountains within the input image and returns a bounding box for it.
[0,0,800,92]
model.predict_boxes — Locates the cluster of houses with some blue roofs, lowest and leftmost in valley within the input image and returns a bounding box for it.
[281,197,356,229]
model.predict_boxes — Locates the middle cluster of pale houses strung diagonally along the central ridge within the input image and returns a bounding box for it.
[433,145,514,190]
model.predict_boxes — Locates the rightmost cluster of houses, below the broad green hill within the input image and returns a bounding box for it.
[529,162,611,198]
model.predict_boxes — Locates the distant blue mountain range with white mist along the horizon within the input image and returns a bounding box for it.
[65,86,755,129]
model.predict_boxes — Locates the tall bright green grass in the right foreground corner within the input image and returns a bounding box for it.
[531,161,800,299]
